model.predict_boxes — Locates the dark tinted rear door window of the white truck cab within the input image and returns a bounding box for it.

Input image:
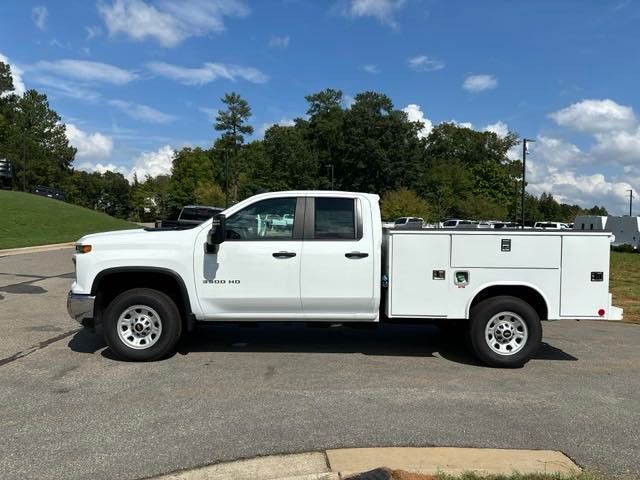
[314,197,356,240]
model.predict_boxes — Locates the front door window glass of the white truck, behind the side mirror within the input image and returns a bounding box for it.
[226,198,296,240]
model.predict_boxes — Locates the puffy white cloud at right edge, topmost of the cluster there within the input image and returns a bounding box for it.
[549,98,637,133]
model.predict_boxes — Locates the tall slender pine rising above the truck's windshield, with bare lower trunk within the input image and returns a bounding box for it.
[214,92,253,201]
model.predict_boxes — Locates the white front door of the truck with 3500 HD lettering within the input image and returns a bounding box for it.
[194,197,304,320]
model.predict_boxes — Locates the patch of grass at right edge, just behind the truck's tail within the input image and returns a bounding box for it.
[609,252,640,323]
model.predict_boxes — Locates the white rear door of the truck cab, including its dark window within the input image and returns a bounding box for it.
[300,197,377,320]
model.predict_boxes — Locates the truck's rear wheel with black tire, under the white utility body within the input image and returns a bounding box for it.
[469,296,542,368]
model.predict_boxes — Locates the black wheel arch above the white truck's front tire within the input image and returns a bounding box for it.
[91,267,195,331]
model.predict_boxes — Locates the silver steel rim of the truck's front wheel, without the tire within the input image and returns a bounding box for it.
[118,305,162,350]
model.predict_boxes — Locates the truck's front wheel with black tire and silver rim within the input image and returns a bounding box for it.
[104,288,182,361]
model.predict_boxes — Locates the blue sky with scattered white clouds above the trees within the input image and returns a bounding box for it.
[0,0,640,213]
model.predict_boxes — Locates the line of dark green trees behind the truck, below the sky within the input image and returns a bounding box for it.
[0,63,607,222]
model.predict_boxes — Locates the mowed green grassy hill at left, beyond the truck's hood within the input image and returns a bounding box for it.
[0,190,138,249]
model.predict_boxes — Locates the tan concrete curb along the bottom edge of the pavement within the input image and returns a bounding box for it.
[153,447,580,480]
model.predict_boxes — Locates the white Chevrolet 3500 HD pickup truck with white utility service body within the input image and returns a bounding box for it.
[67,191,622,367]
